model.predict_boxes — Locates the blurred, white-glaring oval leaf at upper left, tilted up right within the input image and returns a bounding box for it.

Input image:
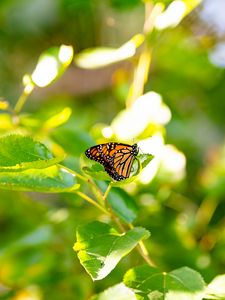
[30,45,73,87]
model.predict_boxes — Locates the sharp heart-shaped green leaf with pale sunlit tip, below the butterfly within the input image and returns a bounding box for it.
[73,221,150,280]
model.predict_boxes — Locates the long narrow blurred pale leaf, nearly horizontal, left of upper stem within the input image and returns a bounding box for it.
[75,34,144,69]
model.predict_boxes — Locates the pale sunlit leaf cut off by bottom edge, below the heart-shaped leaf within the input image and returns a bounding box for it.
[91,283,137,300]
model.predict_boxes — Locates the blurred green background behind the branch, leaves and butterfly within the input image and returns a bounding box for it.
[0,0,225,300]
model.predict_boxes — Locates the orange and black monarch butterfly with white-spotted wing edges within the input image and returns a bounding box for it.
[85,143,139,181]
